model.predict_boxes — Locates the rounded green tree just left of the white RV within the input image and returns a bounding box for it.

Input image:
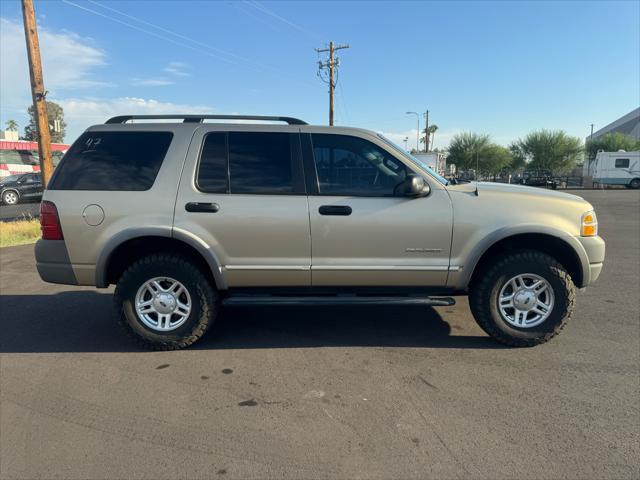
[512,129,583,174]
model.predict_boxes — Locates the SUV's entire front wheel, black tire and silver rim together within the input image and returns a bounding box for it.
[469,250,575,347]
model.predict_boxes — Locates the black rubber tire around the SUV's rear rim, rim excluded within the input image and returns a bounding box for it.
[114,254,218,350]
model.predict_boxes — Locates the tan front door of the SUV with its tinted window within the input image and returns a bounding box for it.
[303,134,452,287]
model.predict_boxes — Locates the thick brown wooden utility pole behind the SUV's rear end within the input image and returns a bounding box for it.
[22,0,53,187]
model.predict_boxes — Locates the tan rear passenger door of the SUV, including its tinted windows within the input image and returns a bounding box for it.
[174,124,311,287]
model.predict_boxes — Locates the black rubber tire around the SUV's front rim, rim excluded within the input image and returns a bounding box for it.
[469,250,576,347]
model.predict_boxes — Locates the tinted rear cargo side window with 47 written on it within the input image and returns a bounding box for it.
[49,132,173,191]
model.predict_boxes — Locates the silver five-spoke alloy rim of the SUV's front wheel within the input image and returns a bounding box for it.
[498,273,554,328]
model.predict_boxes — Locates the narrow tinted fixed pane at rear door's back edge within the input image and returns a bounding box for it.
[196,132,229,193]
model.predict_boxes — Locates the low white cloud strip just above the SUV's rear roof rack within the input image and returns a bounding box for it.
[59,97,213,142]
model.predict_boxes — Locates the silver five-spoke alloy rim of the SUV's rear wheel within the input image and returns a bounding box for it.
[135,277,192,332]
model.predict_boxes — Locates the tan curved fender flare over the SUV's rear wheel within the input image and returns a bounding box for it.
[95,227,227,290]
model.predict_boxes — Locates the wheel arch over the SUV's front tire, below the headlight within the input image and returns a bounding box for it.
[460,232,589,288]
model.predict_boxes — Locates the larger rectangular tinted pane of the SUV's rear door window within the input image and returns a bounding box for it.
[229,132,295,194]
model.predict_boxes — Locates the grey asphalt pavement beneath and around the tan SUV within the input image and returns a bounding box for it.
[0,191,640,479]
